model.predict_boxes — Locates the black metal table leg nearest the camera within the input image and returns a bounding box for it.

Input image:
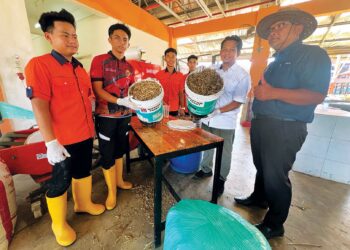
[154,157,163,247]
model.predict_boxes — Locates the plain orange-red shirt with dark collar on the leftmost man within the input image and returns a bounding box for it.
[25,50,95,145]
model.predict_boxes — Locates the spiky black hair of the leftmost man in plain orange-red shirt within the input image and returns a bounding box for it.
[39,9,75,32]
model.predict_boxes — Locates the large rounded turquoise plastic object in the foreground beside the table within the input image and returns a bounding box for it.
[164,200,271,250]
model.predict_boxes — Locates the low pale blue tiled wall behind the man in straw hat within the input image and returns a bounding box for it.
[293,110,350,184]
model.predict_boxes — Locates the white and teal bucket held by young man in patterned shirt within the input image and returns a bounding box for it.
[128,78,164,124]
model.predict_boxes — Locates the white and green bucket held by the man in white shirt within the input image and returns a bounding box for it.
[185,71,224,117]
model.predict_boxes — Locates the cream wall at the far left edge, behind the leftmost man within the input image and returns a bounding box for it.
[0,0,34,129]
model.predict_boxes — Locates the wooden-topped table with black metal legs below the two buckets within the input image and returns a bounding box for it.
[128,117,224,247]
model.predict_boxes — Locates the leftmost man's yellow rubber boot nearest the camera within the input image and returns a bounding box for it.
[46,192,77,247]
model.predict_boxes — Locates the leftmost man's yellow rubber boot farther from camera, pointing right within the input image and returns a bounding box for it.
[72,175,106,215]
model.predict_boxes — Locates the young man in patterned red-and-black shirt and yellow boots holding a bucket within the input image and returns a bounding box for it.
[90,23,137,210]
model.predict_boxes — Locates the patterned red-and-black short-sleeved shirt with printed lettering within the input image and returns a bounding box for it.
[90,51,134,117]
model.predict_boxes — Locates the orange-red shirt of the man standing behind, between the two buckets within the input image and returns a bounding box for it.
[156,68,184,111]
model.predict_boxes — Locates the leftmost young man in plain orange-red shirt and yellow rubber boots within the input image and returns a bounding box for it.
[25,9,105,246]
